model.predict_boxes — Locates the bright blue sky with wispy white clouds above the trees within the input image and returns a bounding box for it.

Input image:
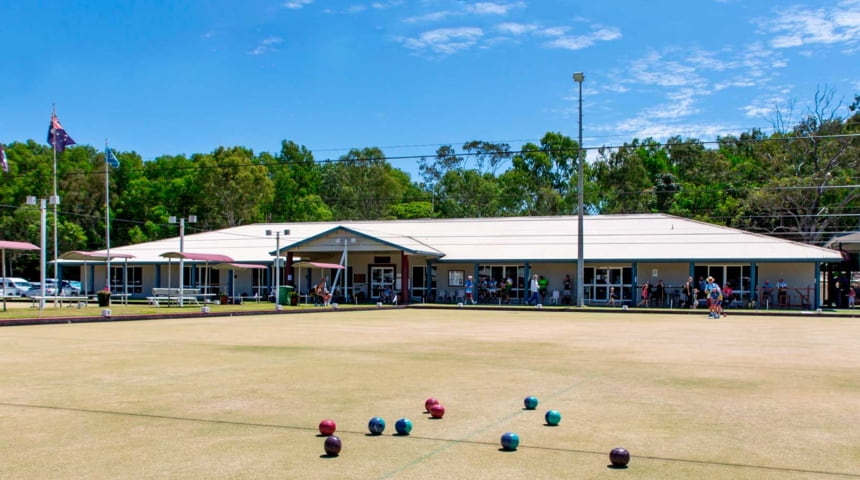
[0,0,860,176]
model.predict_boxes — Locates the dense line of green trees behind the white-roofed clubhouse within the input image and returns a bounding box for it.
[0,92,860,276]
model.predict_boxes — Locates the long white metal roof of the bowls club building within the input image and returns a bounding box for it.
[74,214,841,263]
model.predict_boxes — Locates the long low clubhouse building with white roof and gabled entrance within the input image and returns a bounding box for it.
[60,214,843,308]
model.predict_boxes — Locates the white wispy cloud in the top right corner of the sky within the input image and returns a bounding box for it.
[756,0,860,48]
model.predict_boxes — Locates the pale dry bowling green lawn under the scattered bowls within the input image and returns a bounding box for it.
[0,309,860,480]
